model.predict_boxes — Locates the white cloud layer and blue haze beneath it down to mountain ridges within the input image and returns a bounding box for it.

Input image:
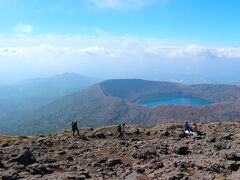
[0,34,240,82]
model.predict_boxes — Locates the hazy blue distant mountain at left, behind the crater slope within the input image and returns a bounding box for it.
[0,73,98,132]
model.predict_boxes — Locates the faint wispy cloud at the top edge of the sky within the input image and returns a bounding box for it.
[87,0,156,9]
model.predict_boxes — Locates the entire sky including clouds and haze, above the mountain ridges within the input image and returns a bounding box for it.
[0,0,240,84]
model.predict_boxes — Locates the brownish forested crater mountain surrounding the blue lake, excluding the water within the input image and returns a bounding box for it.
[6,79,240,134]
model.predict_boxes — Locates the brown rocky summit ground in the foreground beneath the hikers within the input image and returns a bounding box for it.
[0,121,240,180]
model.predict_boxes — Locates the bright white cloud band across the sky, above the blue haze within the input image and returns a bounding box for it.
[0,35,240,59]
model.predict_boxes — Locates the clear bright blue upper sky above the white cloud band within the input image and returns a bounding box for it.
[0,0,240,45]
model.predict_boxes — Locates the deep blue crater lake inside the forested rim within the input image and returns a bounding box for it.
[137,94,211,107]
